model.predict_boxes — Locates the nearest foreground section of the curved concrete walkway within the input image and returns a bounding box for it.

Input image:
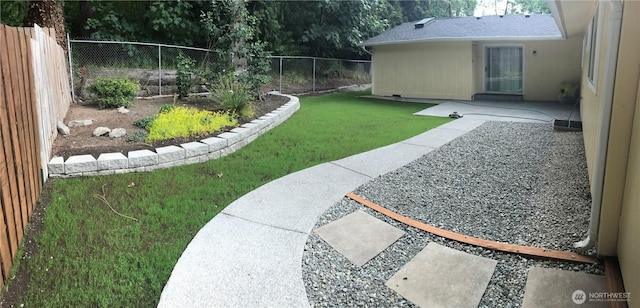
[158,214,309,308]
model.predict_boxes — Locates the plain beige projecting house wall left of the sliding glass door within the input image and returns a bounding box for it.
[372,42,473,100]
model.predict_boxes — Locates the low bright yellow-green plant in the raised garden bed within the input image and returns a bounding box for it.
[146,107,238,142]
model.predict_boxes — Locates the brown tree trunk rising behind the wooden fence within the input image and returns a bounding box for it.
[24,0,68,53]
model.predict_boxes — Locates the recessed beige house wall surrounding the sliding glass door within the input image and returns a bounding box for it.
[472,37,582,101]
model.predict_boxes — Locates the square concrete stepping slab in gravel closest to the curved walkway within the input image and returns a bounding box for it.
[314,211,404,266]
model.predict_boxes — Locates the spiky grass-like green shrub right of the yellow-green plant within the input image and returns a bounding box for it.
[213,73,253,114]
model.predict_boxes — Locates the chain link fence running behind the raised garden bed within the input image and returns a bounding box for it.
[69,40,371,98]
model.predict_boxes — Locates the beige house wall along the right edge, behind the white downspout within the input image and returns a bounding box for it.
[581,0,640,298]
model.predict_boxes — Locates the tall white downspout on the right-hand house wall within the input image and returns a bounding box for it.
[573,0,622,251]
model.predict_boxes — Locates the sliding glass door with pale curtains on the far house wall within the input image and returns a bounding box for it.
[484,46,524,94]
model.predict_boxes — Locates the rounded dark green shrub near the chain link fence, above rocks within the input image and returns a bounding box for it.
[87,78,139,109]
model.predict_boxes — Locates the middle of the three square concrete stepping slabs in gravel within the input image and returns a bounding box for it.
[385,242,498,307]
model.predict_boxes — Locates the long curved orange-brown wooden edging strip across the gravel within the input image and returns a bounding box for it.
[346,192,600,264]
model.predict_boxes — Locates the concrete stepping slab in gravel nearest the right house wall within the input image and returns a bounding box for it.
[522,267,608,308]
